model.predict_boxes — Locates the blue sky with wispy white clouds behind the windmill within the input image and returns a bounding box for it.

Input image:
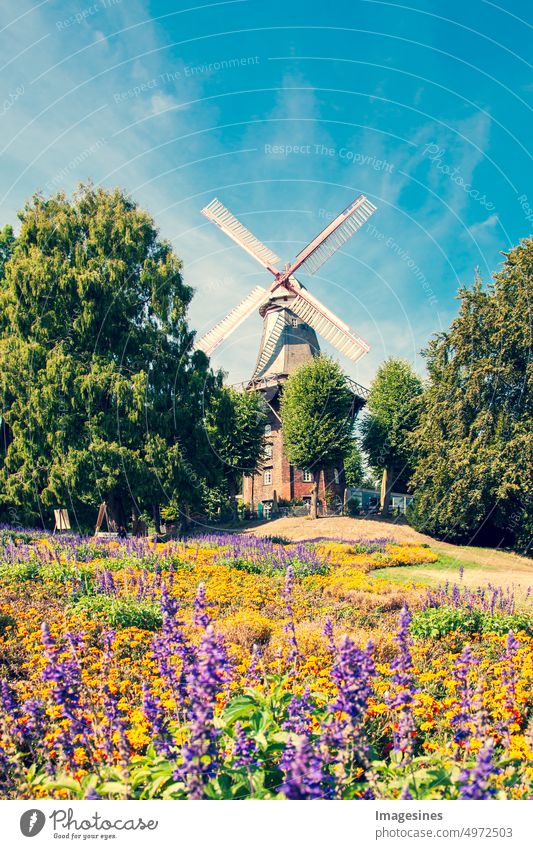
[0,0,533,384]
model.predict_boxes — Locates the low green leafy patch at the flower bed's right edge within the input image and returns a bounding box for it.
[411,605,533,639]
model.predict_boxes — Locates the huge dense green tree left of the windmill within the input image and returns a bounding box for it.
[0,186,221,524]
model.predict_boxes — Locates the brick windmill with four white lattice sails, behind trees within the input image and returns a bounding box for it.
[196,195,376,510]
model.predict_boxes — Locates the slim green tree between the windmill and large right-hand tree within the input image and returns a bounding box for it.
[361,357,422,513]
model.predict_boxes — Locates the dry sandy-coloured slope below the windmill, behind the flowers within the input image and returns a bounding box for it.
[245,516,533,581]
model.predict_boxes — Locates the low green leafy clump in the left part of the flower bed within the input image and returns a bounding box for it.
[73,595,163,631]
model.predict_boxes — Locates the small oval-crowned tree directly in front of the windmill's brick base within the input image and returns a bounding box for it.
[281,355,353,519]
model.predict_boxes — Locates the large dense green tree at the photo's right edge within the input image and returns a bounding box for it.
[410,239,533,551]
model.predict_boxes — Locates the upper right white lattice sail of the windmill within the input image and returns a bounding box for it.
[289,195,377,274]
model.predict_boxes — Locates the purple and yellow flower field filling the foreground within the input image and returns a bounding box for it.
[0,528,533,799]
